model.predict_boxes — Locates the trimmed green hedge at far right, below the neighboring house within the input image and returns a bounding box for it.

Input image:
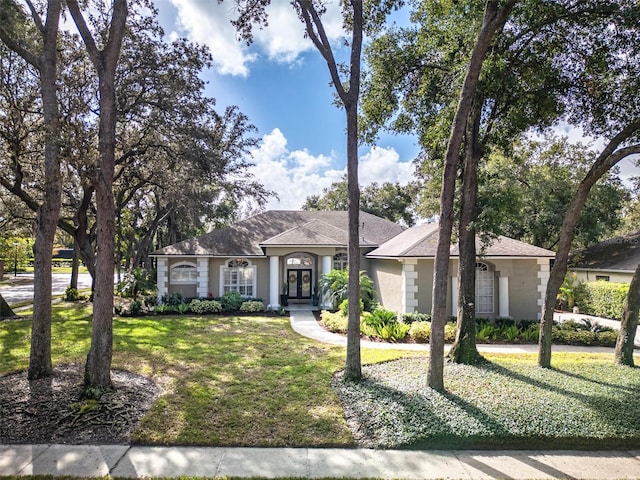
[575,281,629,320]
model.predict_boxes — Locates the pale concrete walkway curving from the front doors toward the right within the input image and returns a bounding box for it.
[289,310,620,354]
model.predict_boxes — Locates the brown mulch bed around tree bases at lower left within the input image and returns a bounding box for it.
[0,364,162,444]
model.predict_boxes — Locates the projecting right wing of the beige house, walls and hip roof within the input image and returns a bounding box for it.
[368,225,553,319]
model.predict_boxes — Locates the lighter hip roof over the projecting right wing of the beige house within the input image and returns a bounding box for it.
[367,223,555,258]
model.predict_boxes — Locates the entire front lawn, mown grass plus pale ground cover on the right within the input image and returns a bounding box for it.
[0,304,640,448]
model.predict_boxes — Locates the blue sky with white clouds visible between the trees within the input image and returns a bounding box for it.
[155,0,640,209]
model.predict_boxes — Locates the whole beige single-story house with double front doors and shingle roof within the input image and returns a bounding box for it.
[152,211,554,319]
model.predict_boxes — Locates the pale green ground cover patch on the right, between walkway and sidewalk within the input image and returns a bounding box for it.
[336,353,640,449]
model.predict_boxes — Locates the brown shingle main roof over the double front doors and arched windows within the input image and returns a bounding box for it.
[151,210,402,257]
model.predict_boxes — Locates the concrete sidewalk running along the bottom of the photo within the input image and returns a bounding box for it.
[0,445,640,479]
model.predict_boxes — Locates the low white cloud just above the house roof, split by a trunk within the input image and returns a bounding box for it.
[251,128,413,210]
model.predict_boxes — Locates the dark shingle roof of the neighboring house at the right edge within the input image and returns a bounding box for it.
[570,231,640,272]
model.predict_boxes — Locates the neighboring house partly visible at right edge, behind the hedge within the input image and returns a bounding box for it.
[569,231,640,283]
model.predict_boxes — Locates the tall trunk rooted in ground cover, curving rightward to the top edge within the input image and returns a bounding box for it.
[427,0,517,391]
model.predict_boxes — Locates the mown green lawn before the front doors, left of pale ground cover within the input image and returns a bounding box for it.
[0,304,416,446]
